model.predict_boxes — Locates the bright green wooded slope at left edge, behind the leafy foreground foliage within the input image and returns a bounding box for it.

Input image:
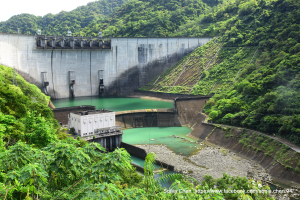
[0,65,58,148]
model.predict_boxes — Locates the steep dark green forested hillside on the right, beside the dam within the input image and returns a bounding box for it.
[142,0,300,145]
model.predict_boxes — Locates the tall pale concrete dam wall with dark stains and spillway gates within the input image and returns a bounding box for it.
[0,33,211,99]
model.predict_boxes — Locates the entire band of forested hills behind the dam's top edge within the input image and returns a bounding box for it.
[0,0,228,37]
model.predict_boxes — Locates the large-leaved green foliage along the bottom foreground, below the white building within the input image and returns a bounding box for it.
[0,144,269,200]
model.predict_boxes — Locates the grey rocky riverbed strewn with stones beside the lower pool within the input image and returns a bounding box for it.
[137,145,271,182]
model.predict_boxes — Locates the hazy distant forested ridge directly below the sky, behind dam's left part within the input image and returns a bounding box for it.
[0,0,129,35]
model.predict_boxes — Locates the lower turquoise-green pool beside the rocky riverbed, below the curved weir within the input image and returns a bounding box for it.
[122,127,201,156]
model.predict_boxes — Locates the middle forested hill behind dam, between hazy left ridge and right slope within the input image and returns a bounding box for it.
[83,0,212,37]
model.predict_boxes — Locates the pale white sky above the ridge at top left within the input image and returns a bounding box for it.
[0,0,95,22]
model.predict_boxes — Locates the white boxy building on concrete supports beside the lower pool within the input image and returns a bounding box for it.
[68,109,123,151]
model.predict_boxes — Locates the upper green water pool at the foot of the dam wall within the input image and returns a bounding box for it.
[52,97,173,112]
